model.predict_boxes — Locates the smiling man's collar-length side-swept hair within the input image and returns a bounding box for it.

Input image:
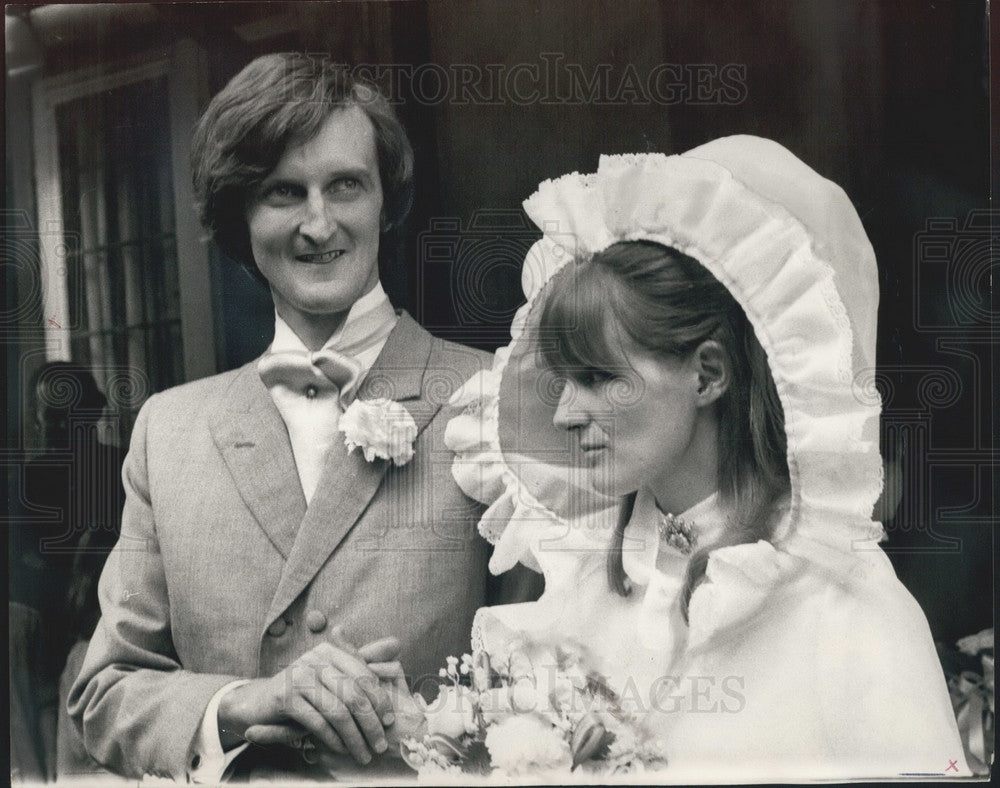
[191,52,413,278]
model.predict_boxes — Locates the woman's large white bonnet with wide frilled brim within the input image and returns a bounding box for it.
[446,136,882,573]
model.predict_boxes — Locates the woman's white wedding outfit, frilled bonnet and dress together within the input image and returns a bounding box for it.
[446,137,968,782]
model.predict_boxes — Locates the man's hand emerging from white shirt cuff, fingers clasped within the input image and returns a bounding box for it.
[219,638,399,765]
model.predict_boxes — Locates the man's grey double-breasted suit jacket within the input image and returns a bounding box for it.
[69,313,489,780]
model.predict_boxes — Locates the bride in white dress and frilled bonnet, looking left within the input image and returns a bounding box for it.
[448,137,969,781]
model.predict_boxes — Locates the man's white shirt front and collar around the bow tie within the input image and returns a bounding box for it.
[261,283,397,503]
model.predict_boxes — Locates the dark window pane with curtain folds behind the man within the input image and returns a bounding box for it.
[56,77,183,418]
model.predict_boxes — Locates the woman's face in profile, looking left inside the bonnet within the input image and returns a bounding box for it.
[552,334,699,496]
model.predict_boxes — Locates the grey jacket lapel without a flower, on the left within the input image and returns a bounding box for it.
[209,364,306,559]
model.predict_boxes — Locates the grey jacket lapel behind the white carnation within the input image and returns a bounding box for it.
[265,312,441,626]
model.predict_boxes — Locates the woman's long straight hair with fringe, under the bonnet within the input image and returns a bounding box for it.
[540,241,790,617]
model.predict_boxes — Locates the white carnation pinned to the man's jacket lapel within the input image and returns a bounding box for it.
[337,398,417,465]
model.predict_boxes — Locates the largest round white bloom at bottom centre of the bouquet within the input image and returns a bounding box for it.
[486,714,573,775]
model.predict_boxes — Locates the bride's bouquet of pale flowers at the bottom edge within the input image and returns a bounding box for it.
[401,641,666,779]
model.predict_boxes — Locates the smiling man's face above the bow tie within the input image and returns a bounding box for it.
[247,107,382,337]
